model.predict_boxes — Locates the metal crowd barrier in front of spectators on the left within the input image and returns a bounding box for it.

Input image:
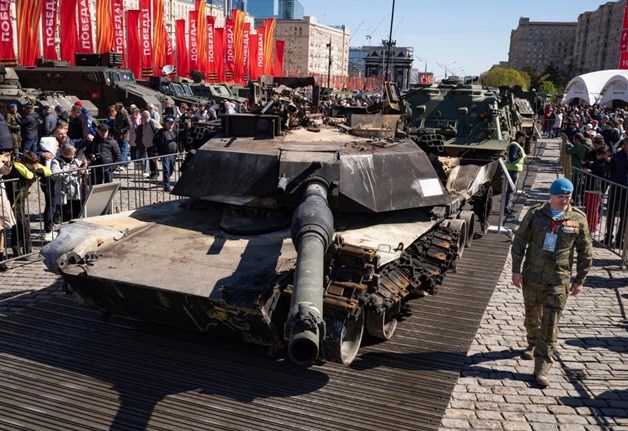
[0,153,185,262]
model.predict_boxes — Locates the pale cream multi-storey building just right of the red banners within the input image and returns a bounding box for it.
[275,16,350,84]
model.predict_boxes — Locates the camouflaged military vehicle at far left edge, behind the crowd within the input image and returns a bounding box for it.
[0,66,98,115]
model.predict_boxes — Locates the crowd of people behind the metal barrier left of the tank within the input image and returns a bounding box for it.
[0,101,215,270]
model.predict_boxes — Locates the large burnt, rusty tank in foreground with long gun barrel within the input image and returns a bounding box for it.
[42,85,496,365]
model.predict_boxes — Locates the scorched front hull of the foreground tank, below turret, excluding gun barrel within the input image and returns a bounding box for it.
[42,202,439,348]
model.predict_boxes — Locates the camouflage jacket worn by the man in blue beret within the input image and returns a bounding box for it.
[511,202,593,285]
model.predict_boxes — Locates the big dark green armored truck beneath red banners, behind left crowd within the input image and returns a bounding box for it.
[15,54,174,117]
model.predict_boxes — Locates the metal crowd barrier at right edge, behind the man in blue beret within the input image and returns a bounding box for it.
[571,167,628,269]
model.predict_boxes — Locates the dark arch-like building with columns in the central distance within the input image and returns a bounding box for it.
[364,40,414,90]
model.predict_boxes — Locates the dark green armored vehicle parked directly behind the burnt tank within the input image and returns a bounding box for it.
[402,78,521,160]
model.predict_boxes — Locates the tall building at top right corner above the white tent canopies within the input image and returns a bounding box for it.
[572,0,626,76]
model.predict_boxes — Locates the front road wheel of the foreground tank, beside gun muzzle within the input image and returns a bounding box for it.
[322,310,364,365]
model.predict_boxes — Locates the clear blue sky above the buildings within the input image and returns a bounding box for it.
[300,0,605,77]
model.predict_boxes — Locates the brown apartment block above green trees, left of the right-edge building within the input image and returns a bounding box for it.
[508,18,577,73]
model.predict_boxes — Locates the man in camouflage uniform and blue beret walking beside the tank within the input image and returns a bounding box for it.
[512,178,593,386]
